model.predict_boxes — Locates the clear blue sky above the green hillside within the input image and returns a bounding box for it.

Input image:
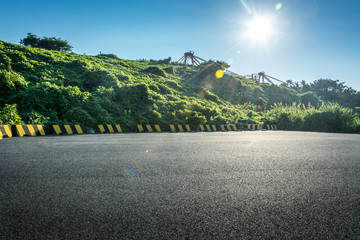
[0,0,360,90]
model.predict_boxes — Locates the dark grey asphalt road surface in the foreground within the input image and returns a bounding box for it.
[0,131,360,239]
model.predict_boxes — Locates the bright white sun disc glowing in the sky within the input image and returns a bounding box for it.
[246,17,273,41]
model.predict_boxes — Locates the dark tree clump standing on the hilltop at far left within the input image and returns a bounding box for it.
[20,33,73,52]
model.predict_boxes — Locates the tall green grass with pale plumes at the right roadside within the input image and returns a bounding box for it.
[265,102,360,133]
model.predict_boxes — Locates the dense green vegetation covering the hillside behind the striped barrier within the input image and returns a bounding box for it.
[0,41,360,132]
